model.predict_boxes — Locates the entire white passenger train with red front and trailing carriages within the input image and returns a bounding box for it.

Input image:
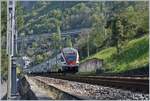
[26,47,79,74]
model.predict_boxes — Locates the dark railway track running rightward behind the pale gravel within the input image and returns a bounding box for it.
[30,74,149,93]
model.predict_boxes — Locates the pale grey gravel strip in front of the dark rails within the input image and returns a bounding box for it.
[33,77,149,100]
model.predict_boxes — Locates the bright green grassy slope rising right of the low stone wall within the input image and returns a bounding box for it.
[82,35,149,73]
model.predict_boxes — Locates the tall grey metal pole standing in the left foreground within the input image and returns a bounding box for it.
[7,0,17,99]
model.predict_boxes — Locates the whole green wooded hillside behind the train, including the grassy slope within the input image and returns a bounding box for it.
[1,1,149,79]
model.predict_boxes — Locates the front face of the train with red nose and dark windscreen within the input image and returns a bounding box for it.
[62,48,79,73]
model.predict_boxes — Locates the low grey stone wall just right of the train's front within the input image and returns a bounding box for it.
[79,58,103,72]
